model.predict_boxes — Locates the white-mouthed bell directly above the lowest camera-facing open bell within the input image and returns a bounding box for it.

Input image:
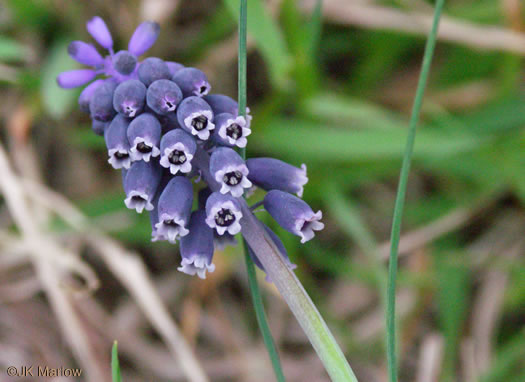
[210,147,252,198]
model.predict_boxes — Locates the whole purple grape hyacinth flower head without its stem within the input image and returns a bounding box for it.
[57,17,323,278]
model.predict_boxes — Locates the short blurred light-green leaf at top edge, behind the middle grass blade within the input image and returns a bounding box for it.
[224,0,292,88]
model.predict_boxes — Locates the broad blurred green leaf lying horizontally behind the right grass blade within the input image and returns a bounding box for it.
[252,119,489,163]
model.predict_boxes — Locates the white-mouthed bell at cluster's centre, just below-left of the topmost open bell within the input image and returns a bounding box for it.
[160,129,197,175]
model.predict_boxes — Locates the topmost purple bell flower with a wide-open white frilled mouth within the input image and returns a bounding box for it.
[177,95,215,141]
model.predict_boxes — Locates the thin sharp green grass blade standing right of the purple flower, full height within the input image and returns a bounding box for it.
[386,0,445,382]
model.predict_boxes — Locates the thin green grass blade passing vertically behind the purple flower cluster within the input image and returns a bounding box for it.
[238,0,285,382]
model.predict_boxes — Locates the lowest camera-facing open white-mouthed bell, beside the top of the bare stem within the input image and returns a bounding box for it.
[206,192,242,235]
